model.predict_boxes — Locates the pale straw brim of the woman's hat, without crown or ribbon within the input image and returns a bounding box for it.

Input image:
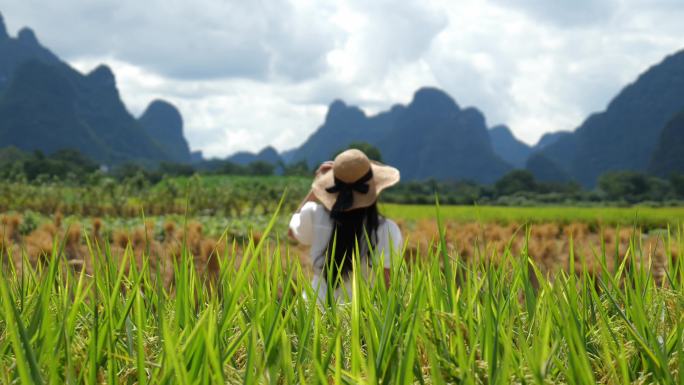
[311,161,400,211]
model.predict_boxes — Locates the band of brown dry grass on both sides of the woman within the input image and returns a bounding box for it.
[0,213,680,288]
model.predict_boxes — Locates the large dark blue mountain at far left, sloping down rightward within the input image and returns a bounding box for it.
[0,17,189,164]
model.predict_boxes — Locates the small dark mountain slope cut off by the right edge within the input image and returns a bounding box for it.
[648,110,684,177]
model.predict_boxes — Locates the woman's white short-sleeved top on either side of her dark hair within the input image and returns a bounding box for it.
[290,202,403,302]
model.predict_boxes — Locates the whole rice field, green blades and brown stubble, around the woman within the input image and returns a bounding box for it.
[0,205,684,384]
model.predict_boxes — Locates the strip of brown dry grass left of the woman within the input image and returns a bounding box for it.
[0,214,310,284]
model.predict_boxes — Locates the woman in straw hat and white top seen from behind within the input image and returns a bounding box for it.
[290,149,402,301]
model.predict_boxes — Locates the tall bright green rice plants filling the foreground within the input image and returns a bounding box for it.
[0,208,684,384]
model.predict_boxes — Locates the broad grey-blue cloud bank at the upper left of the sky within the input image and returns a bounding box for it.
[3,0,335,80]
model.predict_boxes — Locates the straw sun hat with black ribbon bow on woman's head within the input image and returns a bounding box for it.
[311,149,399,212]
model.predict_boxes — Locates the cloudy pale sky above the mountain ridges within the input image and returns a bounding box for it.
[0,0,684,157]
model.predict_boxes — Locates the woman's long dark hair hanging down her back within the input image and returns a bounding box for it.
[325,202,380,282]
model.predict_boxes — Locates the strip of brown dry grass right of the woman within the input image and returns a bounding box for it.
[399,220,679,279]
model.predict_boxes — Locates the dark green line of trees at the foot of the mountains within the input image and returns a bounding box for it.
[0,143,684,205]
